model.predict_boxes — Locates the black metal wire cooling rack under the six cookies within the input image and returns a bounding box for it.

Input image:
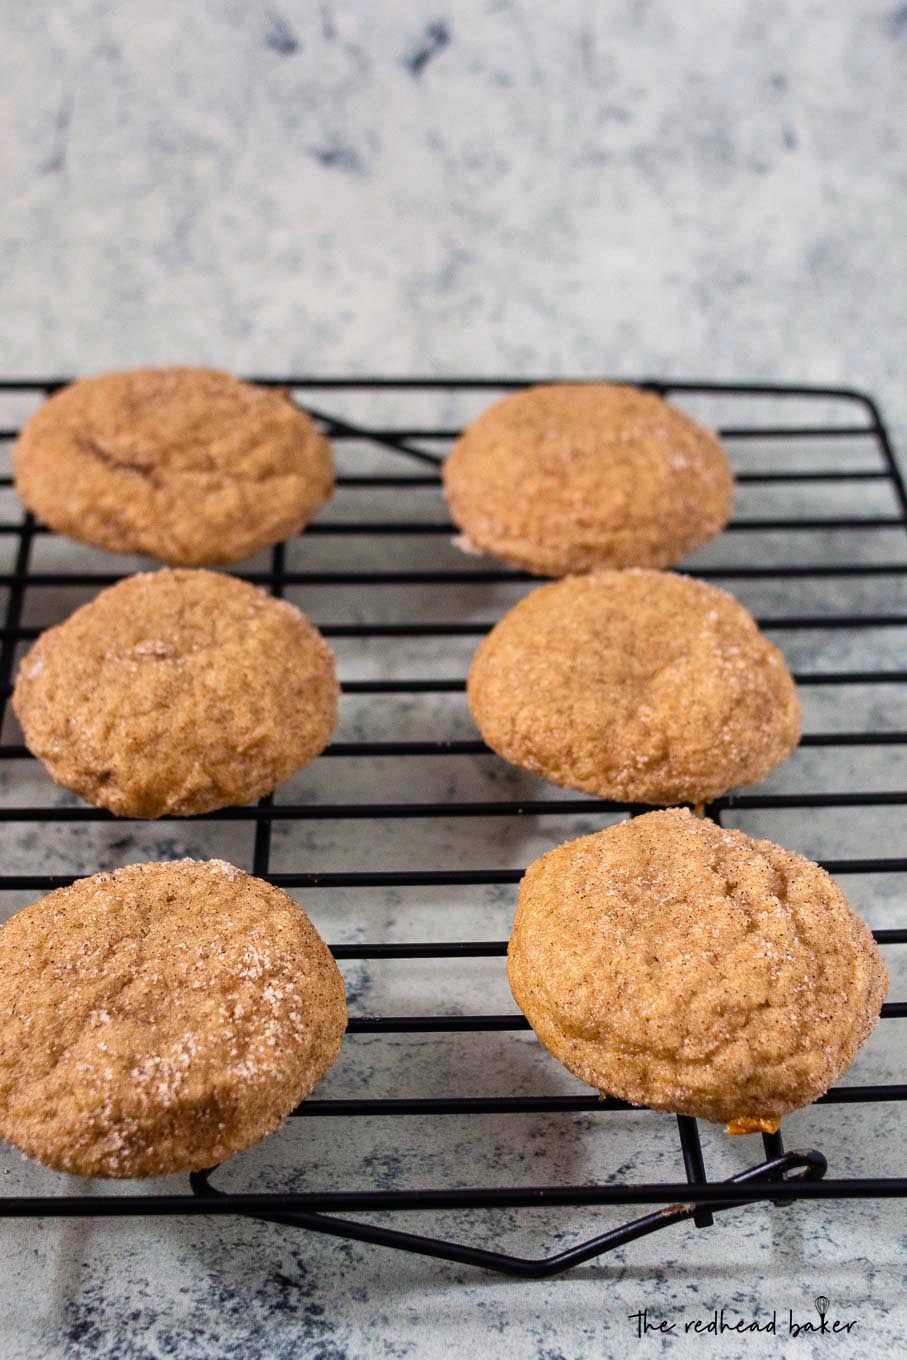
[0,377,907,1277]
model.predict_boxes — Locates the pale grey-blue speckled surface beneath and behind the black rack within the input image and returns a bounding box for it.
[0,0,907,1360]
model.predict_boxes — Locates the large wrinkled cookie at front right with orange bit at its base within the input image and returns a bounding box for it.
[507,808,888,1132]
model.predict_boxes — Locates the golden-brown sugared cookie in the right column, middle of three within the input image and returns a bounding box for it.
[468,571,800,802]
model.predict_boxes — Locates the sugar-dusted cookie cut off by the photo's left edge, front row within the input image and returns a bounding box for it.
[0,860,347,1176]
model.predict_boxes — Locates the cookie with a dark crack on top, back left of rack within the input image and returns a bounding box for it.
[14,369,333,567]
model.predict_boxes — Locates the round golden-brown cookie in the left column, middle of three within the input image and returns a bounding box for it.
[12,568,339,817]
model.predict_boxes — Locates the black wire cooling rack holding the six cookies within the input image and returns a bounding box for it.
[0,377,907,1277]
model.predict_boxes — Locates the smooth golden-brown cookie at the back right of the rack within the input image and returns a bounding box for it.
[443,384,733,577]
